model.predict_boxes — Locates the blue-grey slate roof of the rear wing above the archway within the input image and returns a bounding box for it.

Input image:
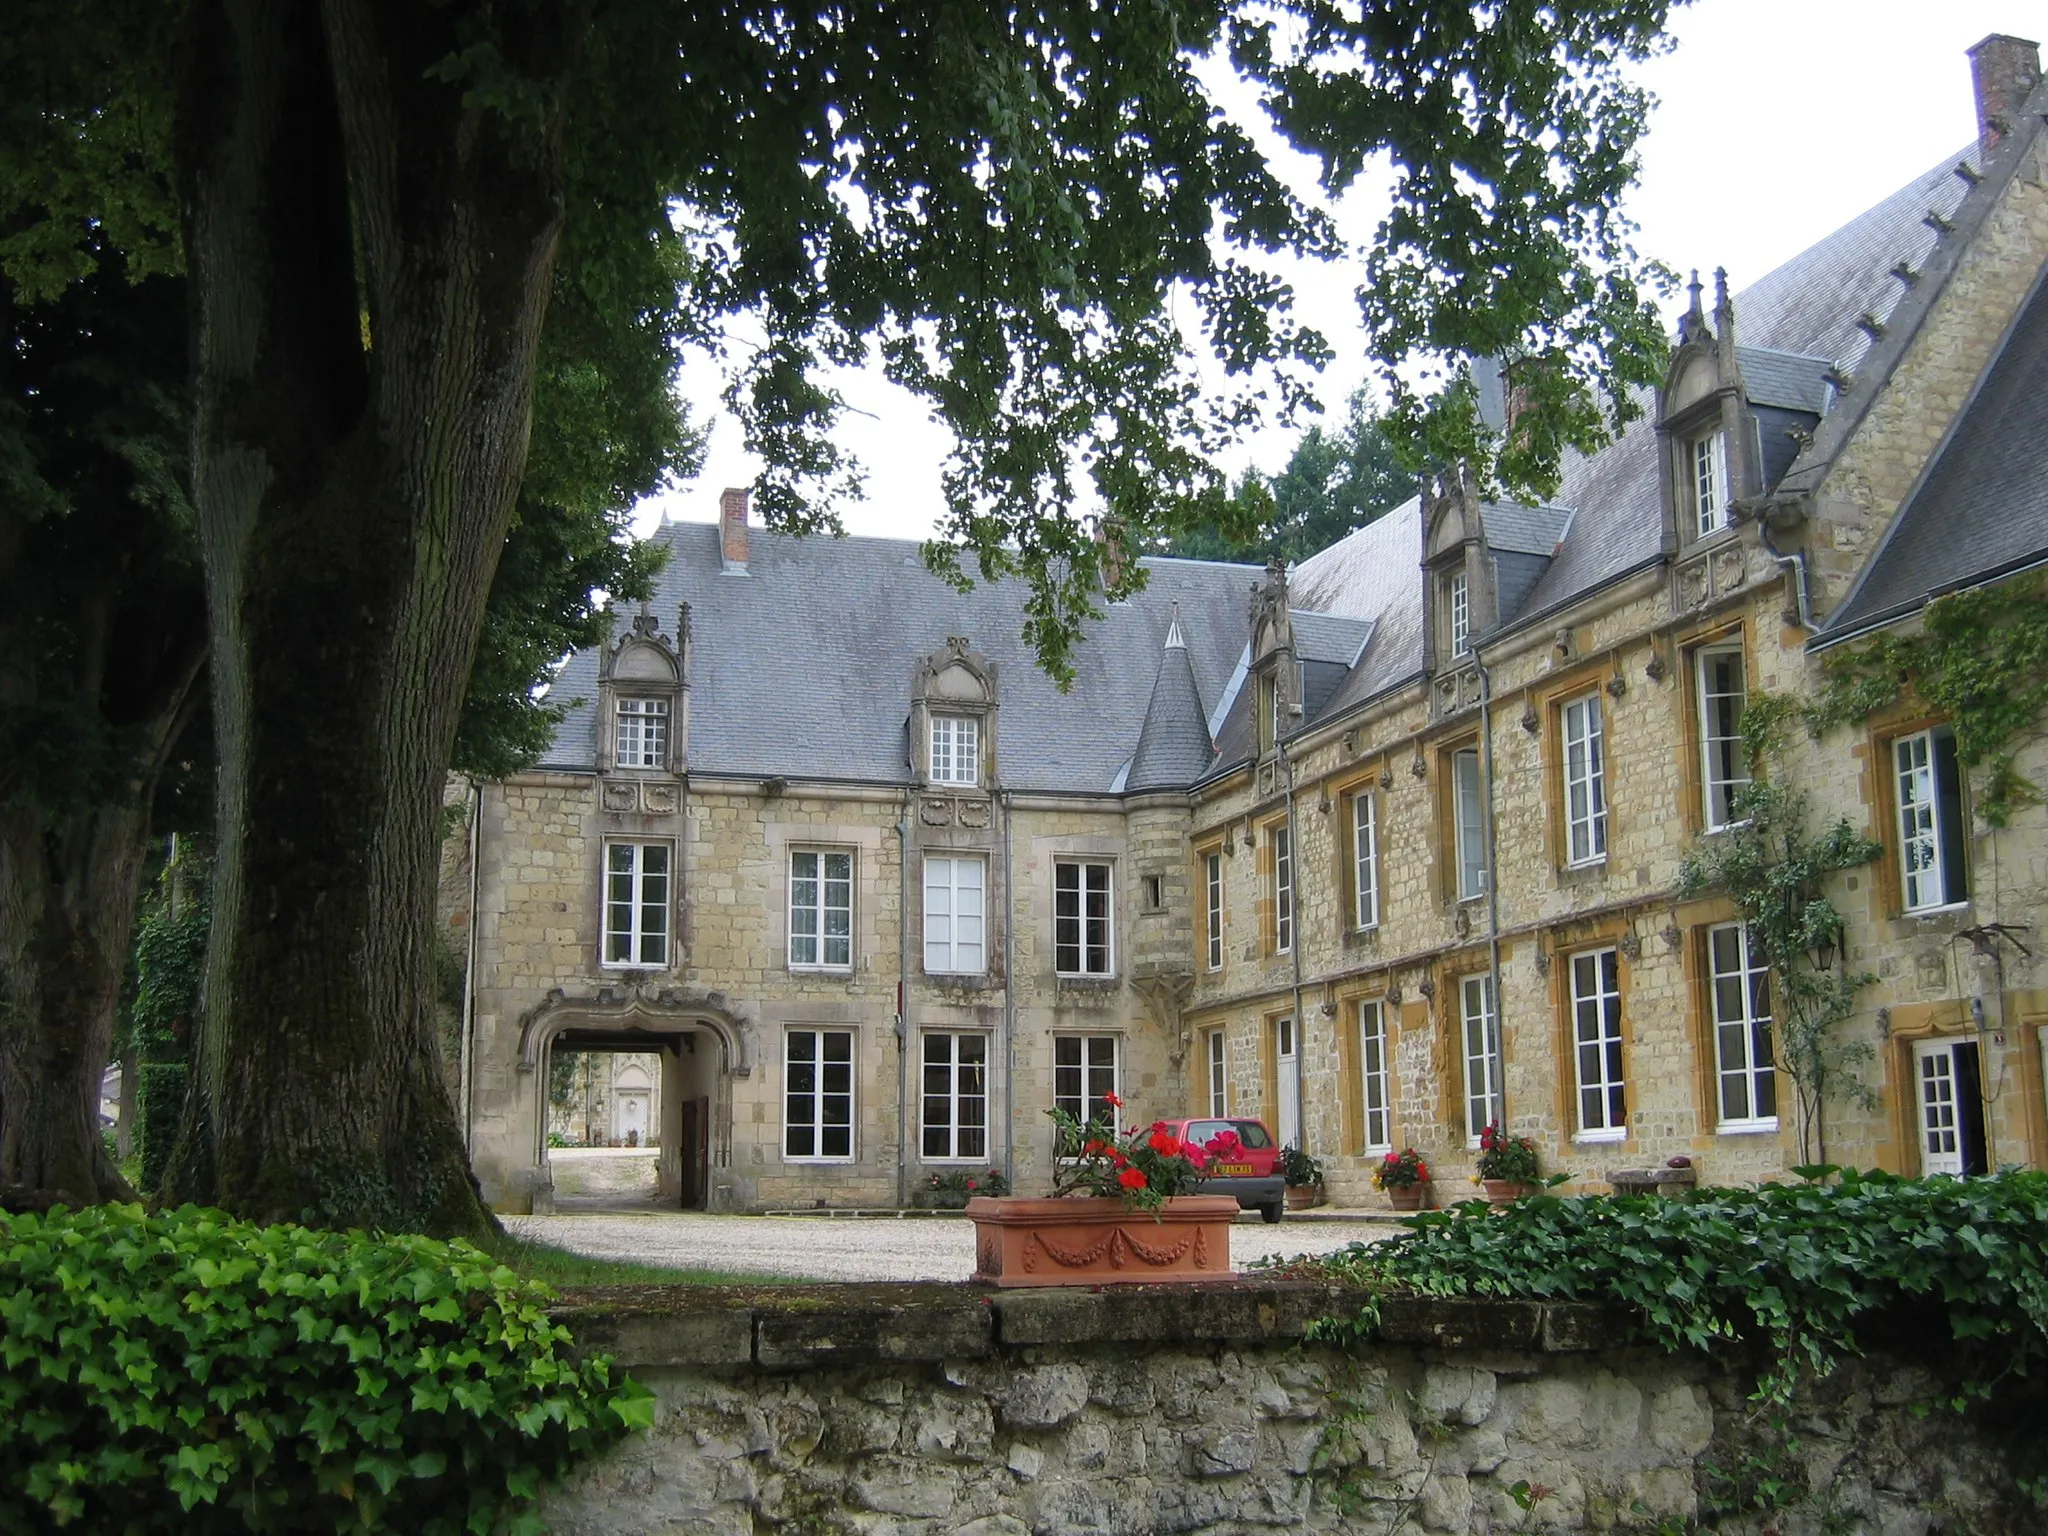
[541,522,1260,795]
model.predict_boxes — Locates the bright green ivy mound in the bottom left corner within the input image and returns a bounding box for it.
[0,1206,653,1536]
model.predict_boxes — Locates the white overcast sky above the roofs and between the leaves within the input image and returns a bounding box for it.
[637,0,2048,539]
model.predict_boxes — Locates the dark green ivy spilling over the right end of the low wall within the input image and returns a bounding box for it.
[1325,1167,2048,1403]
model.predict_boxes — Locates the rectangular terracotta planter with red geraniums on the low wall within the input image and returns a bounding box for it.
[967,1094,1237,1286]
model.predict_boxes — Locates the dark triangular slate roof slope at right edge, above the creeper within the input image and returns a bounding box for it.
[1819,268,2048,645]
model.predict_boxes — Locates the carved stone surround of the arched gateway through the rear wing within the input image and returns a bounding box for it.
[499,983,760,1212]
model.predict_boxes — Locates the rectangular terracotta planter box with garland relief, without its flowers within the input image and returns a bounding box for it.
[967,1194,1237,1286]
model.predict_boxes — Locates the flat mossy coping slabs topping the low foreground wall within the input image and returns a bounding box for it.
[555,1278,1634,1370]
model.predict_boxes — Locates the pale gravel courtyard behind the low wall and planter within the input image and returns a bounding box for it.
[504,1210,1399,1280]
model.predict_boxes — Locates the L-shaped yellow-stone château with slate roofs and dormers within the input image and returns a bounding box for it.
[455,37,2048,1210]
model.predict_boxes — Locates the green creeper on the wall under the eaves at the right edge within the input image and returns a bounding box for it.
[1810,575,2048,827]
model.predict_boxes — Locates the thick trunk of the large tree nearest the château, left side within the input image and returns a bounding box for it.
[172,0,565,1233]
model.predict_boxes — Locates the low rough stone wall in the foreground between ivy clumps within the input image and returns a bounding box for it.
[547,1282,2040,1536]
